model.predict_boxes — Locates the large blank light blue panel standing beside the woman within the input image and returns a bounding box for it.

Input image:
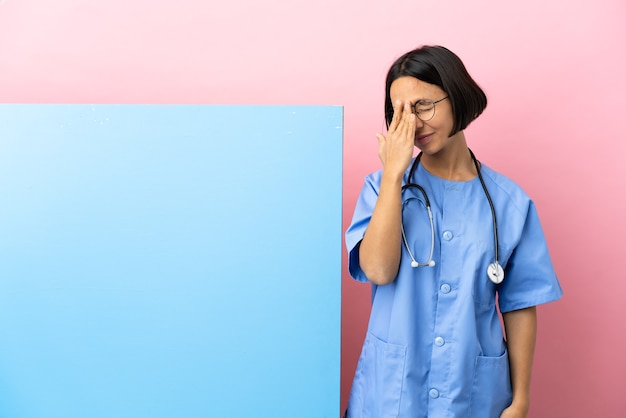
[0,105,342,418]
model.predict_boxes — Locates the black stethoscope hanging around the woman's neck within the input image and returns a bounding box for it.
[400,150,504,284]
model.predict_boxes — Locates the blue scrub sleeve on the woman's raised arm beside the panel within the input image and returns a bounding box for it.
[346,171,378,282]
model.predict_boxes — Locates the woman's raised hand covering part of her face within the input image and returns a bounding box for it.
[376,100,416,177]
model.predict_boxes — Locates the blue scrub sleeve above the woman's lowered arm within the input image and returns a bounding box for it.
[498,201,563,312]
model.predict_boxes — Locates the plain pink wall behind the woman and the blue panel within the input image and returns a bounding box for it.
[0,0,626,418]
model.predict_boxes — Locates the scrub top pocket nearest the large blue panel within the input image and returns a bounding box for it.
[348,333,406,418]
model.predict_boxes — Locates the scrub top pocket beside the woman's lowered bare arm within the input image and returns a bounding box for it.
[469,349,513,418]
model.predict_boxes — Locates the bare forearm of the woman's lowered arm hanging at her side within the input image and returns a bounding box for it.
[502,307,537,417]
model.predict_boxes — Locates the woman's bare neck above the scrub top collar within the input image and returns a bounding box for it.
[420,132,478,181]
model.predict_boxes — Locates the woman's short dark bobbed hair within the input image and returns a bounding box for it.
[385,46,487,136]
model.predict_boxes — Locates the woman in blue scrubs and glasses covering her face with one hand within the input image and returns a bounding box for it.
[346,46,562,418]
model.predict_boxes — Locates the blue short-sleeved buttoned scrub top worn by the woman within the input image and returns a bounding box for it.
[346,164,562,418]
